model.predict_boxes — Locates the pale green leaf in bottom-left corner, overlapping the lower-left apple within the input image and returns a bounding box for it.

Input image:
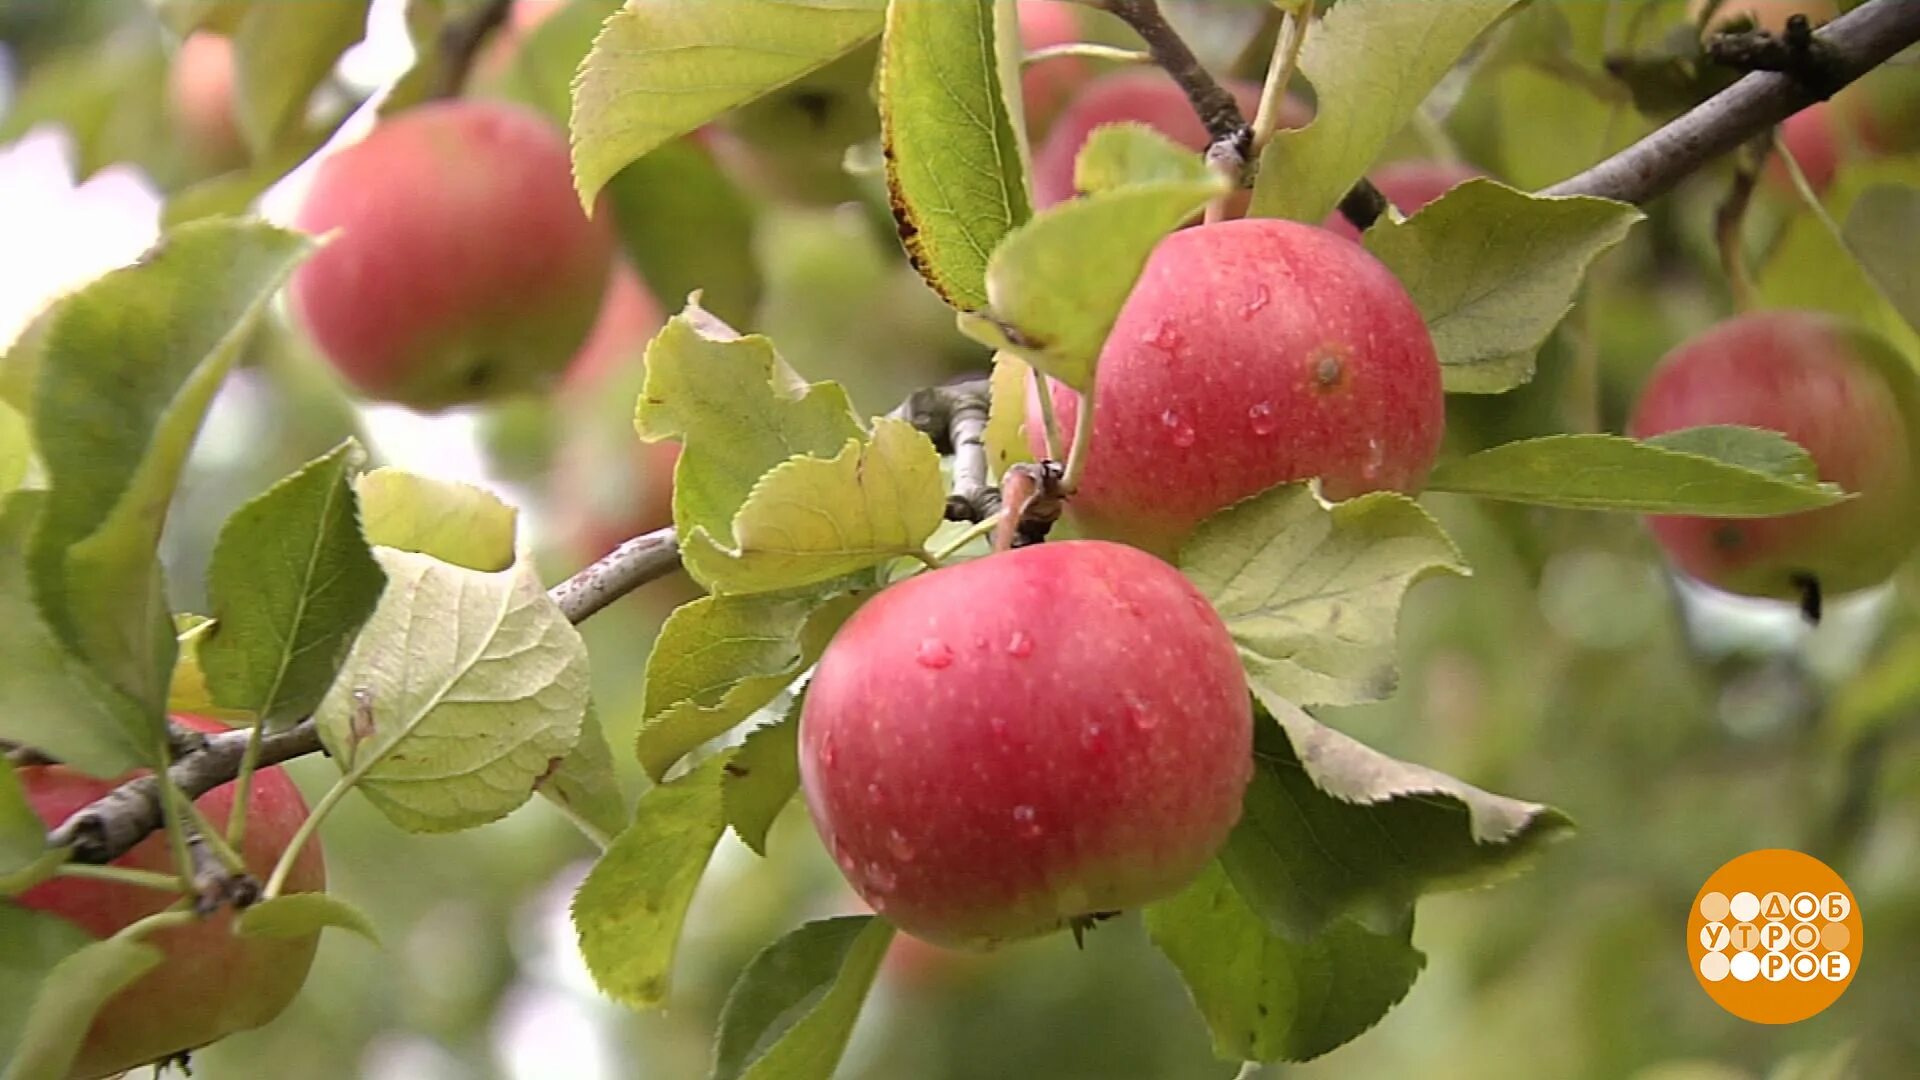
[0,938,165,1080]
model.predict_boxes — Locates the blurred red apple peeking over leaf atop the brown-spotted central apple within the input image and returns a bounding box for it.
[1033,67,1308,209]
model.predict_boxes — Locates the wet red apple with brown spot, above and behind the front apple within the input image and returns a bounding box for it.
[1027,217,1446,555]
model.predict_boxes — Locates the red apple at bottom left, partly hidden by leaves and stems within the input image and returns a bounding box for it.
[17,717,326,1076]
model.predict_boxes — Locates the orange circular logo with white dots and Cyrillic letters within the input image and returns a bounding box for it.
[1686,847,1862,1024]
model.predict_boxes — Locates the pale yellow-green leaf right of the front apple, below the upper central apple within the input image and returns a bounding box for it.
[1181,484,1469,705]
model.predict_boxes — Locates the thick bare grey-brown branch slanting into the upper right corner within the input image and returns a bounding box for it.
[1540,0,1920,204]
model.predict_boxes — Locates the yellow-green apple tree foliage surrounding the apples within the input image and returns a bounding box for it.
[0,0,1920,1080]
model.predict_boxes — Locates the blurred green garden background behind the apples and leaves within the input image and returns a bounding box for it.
[0,0,1920,1080]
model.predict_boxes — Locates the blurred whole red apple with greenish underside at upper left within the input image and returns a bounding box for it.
[292,100,614,409]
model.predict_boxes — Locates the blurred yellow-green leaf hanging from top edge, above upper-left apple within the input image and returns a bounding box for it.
[234,0,371,158]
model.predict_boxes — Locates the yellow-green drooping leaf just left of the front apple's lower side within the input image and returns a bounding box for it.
[574,753,728,1009]
